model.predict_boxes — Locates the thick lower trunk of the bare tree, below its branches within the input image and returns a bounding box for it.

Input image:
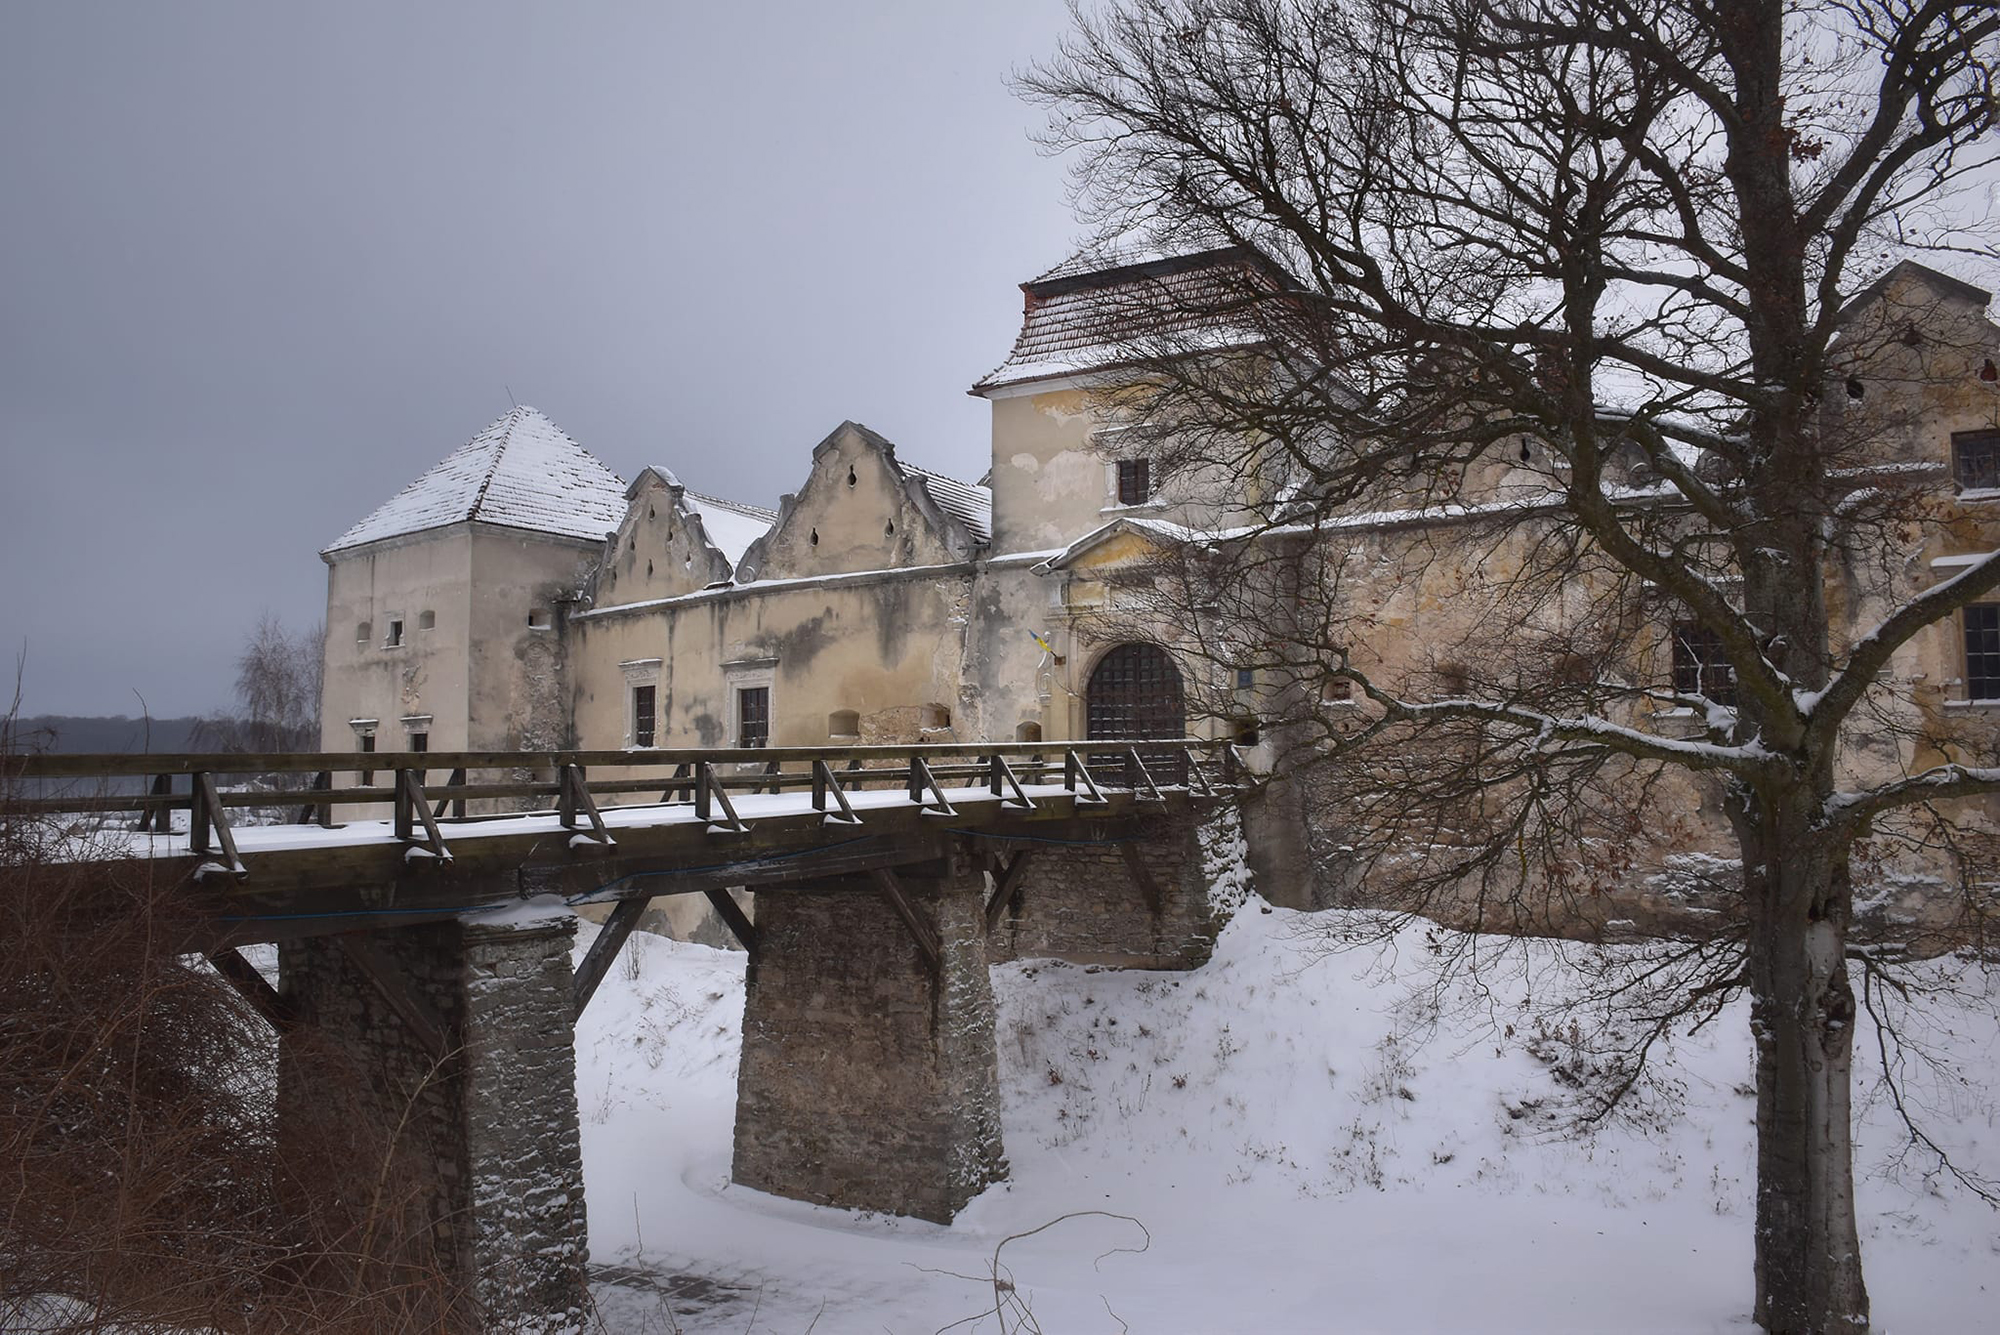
[1744,803,1868,1335]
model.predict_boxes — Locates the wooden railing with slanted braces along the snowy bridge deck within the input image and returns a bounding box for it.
[11,737,1240,873]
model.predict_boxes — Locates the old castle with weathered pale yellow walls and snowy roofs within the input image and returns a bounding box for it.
[322,250,2000,919]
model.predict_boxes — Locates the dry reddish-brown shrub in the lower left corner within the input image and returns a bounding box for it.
[0,739,470,1333]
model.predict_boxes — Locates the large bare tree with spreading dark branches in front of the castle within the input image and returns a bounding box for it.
[1024,0,2000,1333]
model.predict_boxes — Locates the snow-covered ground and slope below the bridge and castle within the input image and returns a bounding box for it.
[578,901,2000,1335]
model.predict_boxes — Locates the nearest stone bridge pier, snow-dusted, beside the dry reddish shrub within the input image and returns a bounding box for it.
[278,917,588,1333]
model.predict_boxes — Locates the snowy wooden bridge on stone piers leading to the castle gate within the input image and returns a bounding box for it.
[0,739,1236,1331]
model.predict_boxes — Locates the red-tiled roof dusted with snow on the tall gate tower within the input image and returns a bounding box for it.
[972,248,1268,394]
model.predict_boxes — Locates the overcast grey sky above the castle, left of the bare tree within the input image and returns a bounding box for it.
[0,0,1078,715]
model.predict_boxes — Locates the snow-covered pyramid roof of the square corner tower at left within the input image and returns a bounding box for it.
[326,408,624,552]
